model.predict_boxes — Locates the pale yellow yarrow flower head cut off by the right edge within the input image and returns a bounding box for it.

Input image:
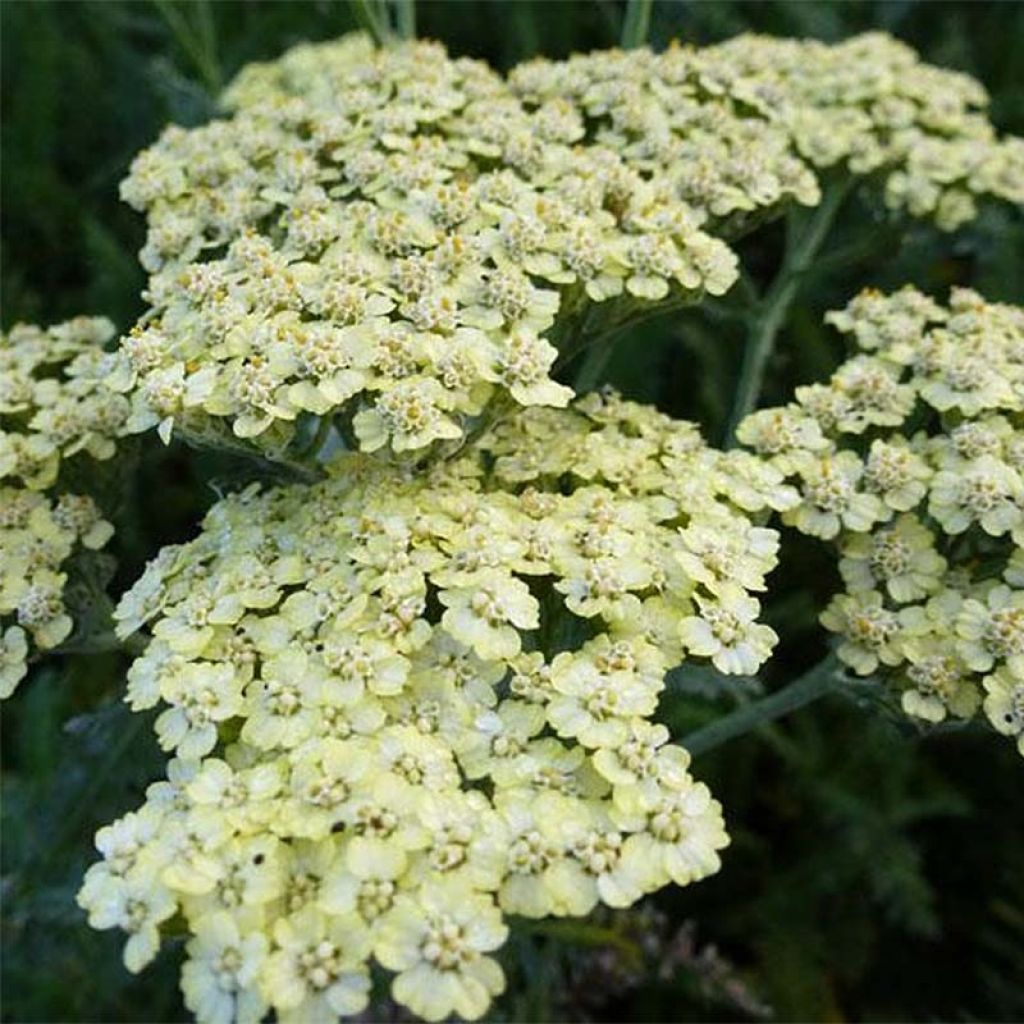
[738,288,1024,754]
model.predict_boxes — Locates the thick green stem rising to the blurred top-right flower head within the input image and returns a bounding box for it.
[725,181,850,447]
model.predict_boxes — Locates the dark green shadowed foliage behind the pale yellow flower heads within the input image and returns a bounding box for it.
[0,0,1024,1021]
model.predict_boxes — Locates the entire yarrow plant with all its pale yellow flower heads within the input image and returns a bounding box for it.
[0,14,1024,1024]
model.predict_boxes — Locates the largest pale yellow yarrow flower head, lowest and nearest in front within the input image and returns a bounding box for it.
[79,392,798,1022]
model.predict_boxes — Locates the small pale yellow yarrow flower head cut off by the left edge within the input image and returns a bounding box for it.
[0,316,123,698]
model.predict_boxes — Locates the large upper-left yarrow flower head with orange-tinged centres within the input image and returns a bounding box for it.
[116,37,735,453]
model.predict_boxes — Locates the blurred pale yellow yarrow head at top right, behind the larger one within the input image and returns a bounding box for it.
[510,33,1024,237]
